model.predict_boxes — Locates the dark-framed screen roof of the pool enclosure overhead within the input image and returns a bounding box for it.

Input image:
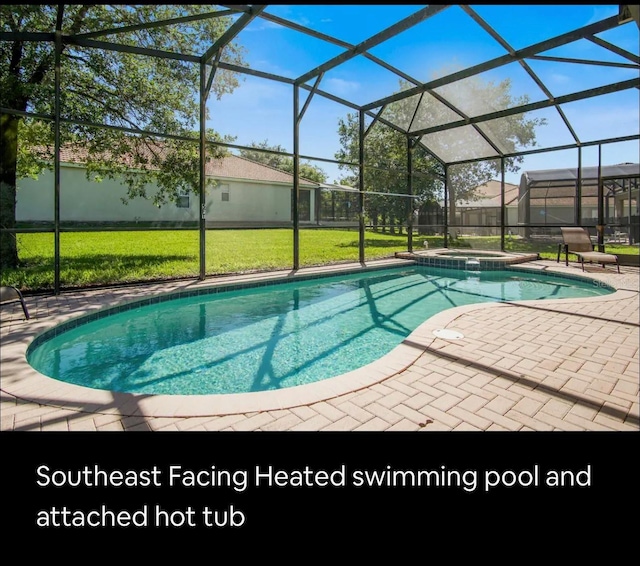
[0,4,640,168]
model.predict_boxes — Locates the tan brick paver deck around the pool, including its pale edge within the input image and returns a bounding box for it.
[0,261,640,432]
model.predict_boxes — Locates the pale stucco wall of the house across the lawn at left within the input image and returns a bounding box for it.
[16,165,315,222]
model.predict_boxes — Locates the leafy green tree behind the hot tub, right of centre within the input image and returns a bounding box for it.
[336,76,545,233]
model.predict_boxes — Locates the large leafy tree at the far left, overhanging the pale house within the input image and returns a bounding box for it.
[0,5,243,268]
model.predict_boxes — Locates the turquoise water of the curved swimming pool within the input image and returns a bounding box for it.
[27,266,612,395]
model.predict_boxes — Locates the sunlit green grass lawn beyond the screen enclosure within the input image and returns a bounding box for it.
[2,229,638,291]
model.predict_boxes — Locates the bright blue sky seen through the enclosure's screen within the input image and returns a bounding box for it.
[207,4,640,183]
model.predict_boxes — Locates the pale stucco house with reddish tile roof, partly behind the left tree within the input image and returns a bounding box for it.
[16,148,319,227]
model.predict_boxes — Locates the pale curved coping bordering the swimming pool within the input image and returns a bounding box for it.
[1,259,635,417]
